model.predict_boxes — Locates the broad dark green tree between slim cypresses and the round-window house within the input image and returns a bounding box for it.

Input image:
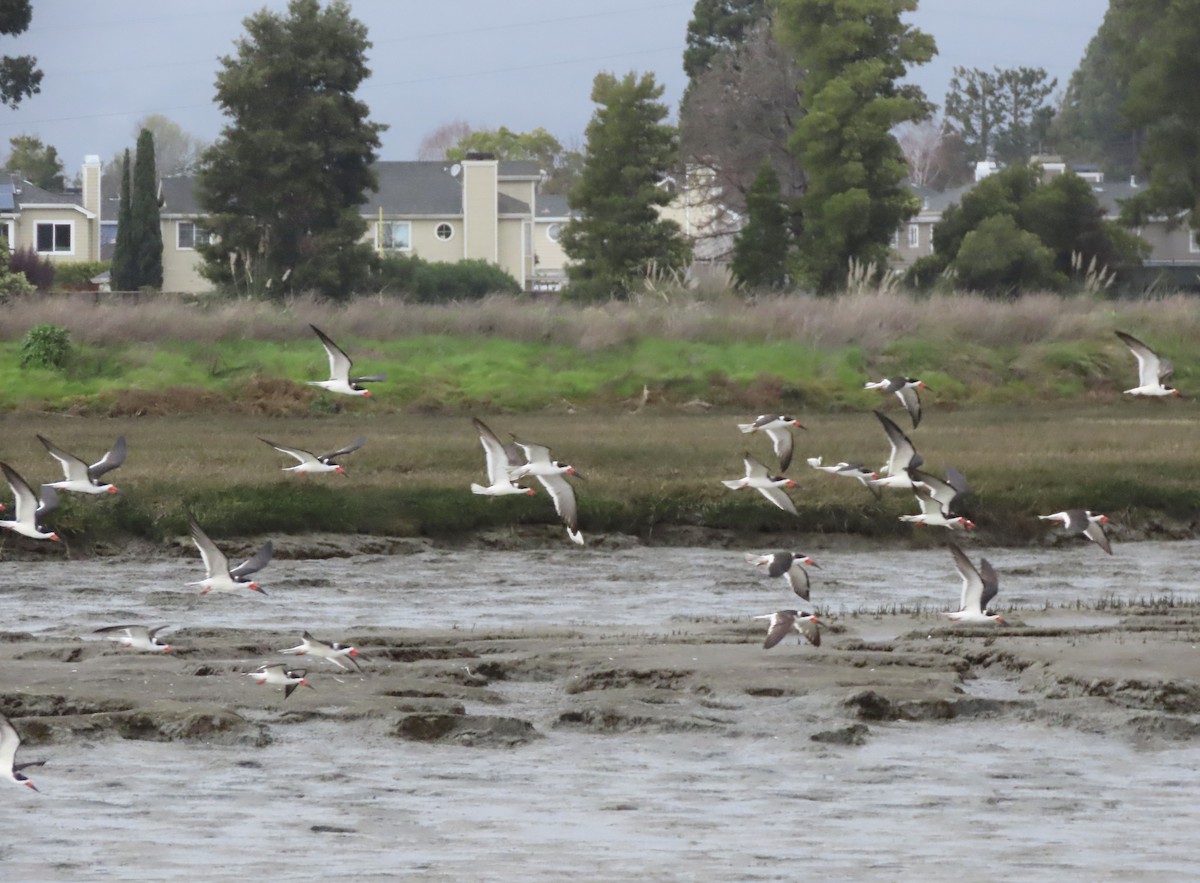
[197,0,384,298]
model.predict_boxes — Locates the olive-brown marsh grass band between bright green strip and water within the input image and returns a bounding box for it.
[9,402,1200,546]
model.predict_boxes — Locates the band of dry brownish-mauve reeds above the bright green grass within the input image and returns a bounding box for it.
[0,288,1200,352]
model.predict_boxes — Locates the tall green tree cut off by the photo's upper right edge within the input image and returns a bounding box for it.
[1105,0,1200,249]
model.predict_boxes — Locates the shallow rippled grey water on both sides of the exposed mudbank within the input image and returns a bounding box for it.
[0,541,1200,883]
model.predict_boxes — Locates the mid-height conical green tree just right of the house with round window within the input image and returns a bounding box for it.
[560,72,691,300]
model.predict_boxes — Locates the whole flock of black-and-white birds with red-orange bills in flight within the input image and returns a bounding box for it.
[0,325,1180,791]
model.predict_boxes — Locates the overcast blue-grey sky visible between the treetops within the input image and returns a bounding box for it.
[0,0,1108,174]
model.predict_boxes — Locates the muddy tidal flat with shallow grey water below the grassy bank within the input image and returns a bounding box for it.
[0,540,1200,882]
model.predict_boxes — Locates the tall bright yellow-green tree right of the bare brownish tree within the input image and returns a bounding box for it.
[775,0,936,292]
